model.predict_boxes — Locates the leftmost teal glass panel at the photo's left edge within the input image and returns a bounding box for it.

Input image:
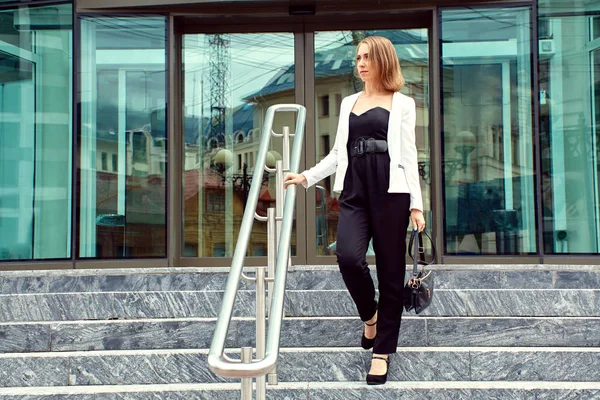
[0,4,73,260]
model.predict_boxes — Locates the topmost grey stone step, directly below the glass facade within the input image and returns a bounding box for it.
[0,265,600,294]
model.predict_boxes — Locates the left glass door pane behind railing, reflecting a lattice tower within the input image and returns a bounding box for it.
[182,33,296,257]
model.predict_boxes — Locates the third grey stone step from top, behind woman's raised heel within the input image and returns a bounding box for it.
[0,316,600,353]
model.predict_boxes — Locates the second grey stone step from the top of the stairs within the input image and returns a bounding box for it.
[0,289,600,322]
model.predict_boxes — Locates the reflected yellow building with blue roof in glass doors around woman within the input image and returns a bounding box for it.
[234,30,429,254]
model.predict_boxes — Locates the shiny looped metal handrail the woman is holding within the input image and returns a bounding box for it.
[208,104,306,400]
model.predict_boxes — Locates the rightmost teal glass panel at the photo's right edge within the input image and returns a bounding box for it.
[539,0,600,253]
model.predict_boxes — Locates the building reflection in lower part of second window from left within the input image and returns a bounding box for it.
[95,127,167,258]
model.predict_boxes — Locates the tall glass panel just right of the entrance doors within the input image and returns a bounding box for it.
[441,8,536,254]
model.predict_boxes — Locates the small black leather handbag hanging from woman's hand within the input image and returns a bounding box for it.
[404,229,436,314]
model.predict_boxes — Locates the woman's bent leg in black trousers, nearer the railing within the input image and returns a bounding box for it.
[335,201,377,321]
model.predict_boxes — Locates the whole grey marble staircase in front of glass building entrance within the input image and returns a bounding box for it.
[0,265,600,400]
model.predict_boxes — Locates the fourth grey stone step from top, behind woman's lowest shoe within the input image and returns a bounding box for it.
[0,347,600,387]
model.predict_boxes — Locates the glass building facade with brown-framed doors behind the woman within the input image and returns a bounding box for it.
[0,0,600,270]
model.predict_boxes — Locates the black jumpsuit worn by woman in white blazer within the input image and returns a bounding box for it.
[336,107,410,354]
